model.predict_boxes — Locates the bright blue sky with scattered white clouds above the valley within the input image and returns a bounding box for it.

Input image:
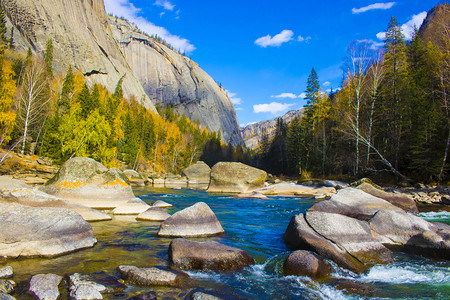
[104,0,439,125]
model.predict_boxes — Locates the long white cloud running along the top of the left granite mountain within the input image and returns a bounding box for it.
[105,0,195,53]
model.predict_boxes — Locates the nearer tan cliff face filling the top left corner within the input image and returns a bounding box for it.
[2,0,156,111]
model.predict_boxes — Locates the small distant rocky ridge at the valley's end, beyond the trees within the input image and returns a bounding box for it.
[241,108,304,149]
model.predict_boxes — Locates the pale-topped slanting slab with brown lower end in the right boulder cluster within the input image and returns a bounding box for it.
[305,211,393,267]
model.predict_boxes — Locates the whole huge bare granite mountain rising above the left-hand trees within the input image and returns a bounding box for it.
[1,0,242,145]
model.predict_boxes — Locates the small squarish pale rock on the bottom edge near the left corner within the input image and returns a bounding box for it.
[29,274,62,300]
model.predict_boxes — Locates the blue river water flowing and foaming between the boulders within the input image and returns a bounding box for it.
[8,189,450,299]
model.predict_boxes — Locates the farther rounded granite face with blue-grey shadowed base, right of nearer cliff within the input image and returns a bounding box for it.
[109,17,243,145]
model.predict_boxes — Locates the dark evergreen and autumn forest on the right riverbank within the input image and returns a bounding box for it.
[259,5,450,182]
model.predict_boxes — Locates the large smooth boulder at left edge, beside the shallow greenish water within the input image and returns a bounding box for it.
[0,203,97,257]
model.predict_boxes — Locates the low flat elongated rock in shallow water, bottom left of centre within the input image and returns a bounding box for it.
[117,266,189,287]
